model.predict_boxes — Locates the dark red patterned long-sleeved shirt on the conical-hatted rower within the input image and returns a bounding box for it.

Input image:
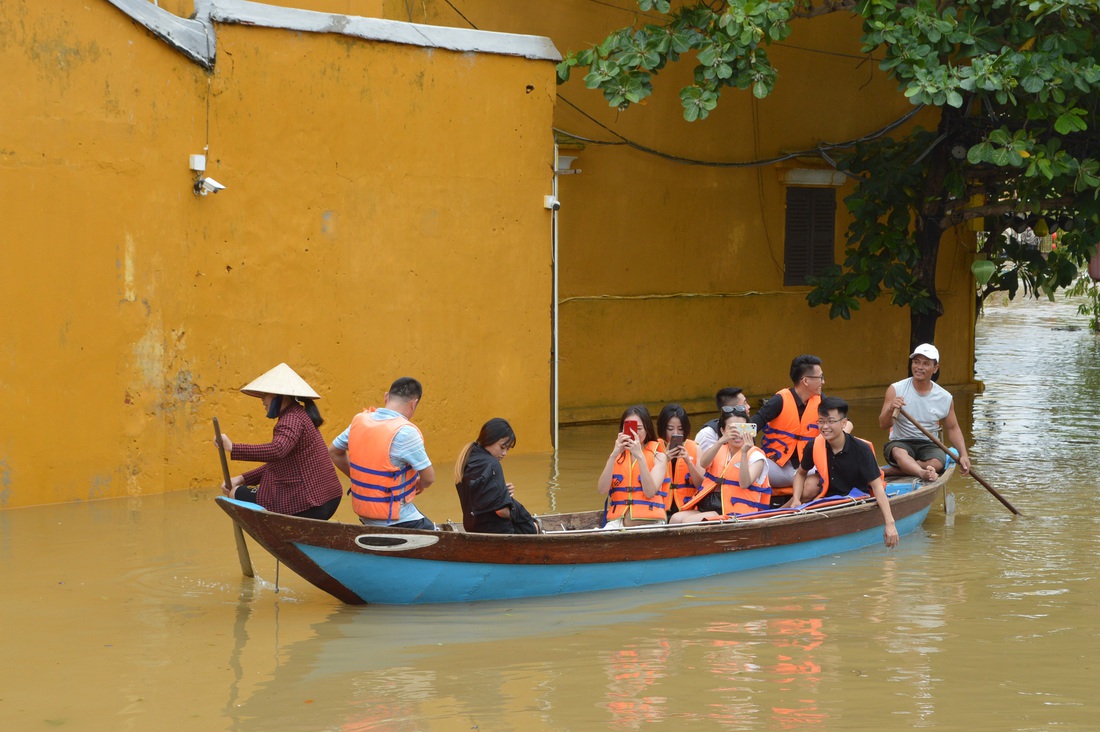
[227,404,343,514]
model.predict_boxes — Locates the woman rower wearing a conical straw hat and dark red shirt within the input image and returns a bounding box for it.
[211,363,343,521]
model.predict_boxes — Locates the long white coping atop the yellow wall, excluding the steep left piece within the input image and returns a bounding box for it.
[209,0,561,62]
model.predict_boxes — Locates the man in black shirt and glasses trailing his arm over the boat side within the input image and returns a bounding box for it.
[791,396,898,546]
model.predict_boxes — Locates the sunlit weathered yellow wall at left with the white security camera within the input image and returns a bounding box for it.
[0,0,554,507]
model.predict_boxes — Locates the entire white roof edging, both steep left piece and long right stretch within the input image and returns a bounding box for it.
[107,0,561,68]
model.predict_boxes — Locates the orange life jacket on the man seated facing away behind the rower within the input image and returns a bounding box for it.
[348,407,420,521]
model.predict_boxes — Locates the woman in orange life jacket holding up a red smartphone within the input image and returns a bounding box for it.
[596,404,668,528]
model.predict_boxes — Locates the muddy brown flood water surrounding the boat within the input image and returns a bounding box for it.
[0,302,1100,732]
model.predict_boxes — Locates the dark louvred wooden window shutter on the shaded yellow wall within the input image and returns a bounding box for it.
[783,187,836,285]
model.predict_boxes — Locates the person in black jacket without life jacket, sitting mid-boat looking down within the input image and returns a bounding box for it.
[454,417,539,534]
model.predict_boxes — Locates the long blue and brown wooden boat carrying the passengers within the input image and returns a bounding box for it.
[217,468,953,604]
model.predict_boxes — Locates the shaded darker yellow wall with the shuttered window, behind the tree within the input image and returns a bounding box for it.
[398,0,974,420]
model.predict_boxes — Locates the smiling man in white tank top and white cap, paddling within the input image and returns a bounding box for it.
[879,343,970,481]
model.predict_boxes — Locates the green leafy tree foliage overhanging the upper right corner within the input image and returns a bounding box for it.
[558,0,1100,343]
